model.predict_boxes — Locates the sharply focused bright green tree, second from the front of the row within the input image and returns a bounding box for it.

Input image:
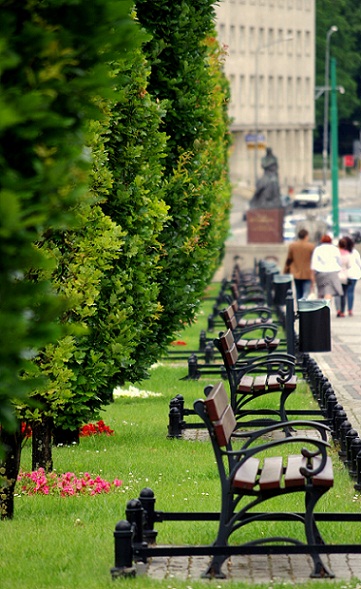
[24,50,167,450]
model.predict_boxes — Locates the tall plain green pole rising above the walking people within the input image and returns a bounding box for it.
[331,57,339,238]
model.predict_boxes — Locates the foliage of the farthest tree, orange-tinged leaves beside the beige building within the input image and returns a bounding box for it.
[136,0,231,341]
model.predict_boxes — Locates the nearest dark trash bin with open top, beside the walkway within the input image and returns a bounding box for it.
[298,299,331,352]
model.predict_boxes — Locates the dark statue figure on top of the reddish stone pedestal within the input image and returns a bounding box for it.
[249,147,282,209]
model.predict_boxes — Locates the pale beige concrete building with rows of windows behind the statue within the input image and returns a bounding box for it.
[216,0,315,192]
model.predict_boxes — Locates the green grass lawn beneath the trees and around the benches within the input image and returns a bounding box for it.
[0,282,361,589]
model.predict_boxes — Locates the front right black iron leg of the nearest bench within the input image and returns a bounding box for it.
[305,488,335,579]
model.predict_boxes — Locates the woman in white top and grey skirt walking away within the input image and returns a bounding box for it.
[311,235,343,299]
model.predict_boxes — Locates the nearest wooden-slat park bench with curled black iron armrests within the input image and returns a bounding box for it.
[194,382,334,577]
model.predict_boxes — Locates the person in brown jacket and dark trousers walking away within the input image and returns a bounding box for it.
[284,229,315,300]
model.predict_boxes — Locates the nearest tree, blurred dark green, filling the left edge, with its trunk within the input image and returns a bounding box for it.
[0,0,137,517]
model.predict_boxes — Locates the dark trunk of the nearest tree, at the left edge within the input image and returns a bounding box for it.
[0,423,22,520]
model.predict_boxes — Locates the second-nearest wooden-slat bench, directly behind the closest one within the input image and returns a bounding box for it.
[214,329,297,426]
